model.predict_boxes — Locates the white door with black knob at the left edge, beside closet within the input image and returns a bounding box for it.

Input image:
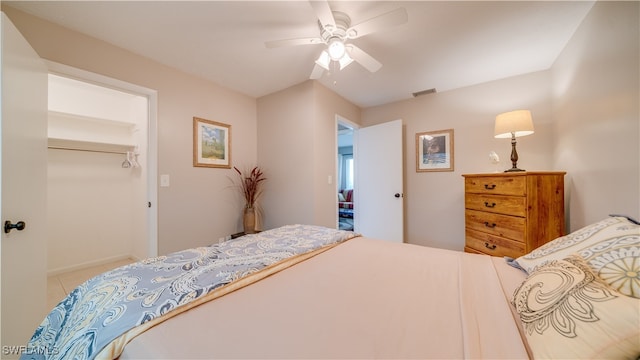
[0,13,47,357]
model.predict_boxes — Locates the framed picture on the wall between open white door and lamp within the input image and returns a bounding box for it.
[416,129,453,172]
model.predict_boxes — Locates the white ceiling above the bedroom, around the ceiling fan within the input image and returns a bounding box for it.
[4,0,593,107]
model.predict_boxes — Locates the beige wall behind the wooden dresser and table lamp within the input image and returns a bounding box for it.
[362,72,555,250]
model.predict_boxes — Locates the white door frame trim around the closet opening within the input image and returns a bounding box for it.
[43,59,158,257]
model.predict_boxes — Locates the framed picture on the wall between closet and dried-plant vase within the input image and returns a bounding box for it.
[193,117,231,168]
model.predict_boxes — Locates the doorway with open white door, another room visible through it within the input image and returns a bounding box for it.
[336,116,404,242]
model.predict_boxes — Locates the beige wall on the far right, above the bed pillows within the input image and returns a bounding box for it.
[553,1,640,229]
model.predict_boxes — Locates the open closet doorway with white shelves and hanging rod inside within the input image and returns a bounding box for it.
[47,64,157,275]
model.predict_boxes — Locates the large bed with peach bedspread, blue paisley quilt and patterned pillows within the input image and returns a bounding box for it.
[22,217,640,360]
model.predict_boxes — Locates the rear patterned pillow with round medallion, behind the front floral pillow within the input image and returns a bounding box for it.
[514,216,640,298]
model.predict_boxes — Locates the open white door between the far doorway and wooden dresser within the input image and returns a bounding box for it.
[354,120,404,242]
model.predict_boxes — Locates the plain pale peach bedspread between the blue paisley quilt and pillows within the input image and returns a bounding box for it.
[120,238,527,359]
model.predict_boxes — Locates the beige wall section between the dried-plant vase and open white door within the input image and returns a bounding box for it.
[258,81,360,229]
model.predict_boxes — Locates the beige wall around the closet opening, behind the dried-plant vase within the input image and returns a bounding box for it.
[2,7,257,254]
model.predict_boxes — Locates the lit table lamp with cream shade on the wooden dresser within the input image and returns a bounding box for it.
[494,110,533,172]
